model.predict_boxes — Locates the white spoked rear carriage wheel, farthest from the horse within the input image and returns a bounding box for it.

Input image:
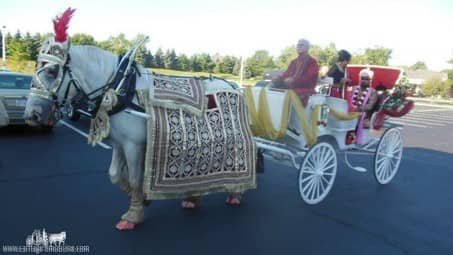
[374,128,403,184]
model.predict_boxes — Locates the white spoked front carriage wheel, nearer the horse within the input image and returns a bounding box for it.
[299,142,337,205]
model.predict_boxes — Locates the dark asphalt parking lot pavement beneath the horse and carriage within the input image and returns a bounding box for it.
[0,106,453,255]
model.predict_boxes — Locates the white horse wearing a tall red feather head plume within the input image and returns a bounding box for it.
[25,8,254,230]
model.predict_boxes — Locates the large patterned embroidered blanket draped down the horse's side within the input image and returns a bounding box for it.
[139,88,256,199]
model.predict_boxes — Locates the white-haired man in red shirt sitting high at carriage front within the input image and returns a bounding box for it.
[273,39,319,106]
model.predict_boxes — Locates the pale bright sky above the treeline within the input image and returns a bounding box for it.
[0,0,453,71]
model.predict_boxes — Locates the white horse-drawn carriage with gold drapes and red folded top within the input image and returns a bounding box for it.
[246,66,403,204]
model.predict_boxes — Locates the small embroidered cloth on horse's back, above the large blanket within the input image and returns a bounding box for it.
[153,75,206,116]
